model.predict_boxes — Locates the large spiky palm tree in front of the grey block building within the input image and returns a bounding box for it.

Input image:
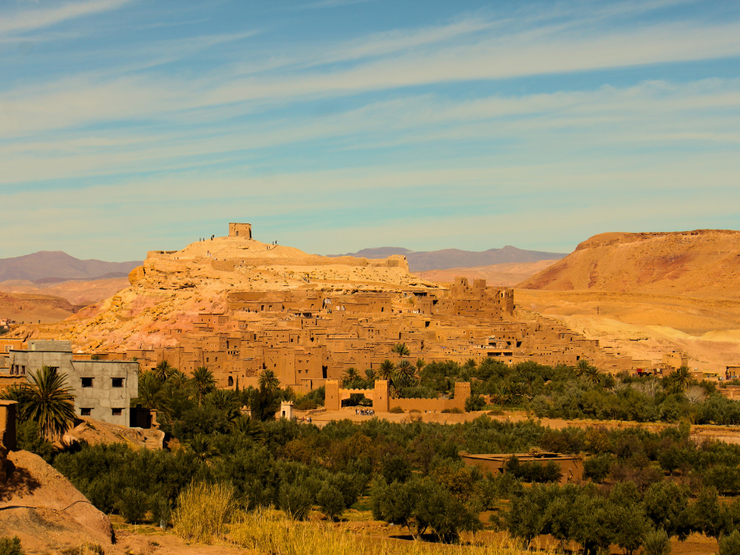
[21,366,75,441]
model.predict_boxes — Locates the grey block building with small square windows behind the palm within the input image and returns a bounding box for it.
[8,340,139,426]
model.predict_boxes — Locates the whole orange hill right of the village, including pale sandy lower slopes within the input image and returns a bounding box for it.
[515,230,740,374]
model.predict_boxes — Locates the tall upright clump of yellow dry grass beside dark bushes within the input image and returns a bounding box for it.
[172,482,234,543]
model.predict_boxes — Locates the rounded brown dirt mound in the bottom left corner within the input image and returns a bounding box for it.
[0,451,113,552]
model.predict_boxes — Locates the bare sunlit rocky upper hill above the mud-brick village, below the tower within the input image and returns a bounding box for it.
[17,230,439,351]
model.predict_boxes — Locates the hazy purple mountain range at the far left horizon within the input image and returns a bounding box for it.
[0,251,141,283]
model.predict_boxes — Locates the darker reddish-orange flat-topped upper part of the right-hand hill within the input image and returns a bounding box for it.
[517,230,740,299]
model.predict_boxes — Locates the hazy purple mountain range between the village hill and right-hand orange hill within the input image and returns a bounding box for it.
[327,245,566,272]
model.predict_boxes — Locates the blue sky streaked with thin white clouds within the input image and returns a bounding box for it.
[0,0,740,260]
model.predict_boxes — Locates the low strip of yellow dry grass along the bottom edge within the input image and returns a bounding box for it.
[227,511,554,555]
